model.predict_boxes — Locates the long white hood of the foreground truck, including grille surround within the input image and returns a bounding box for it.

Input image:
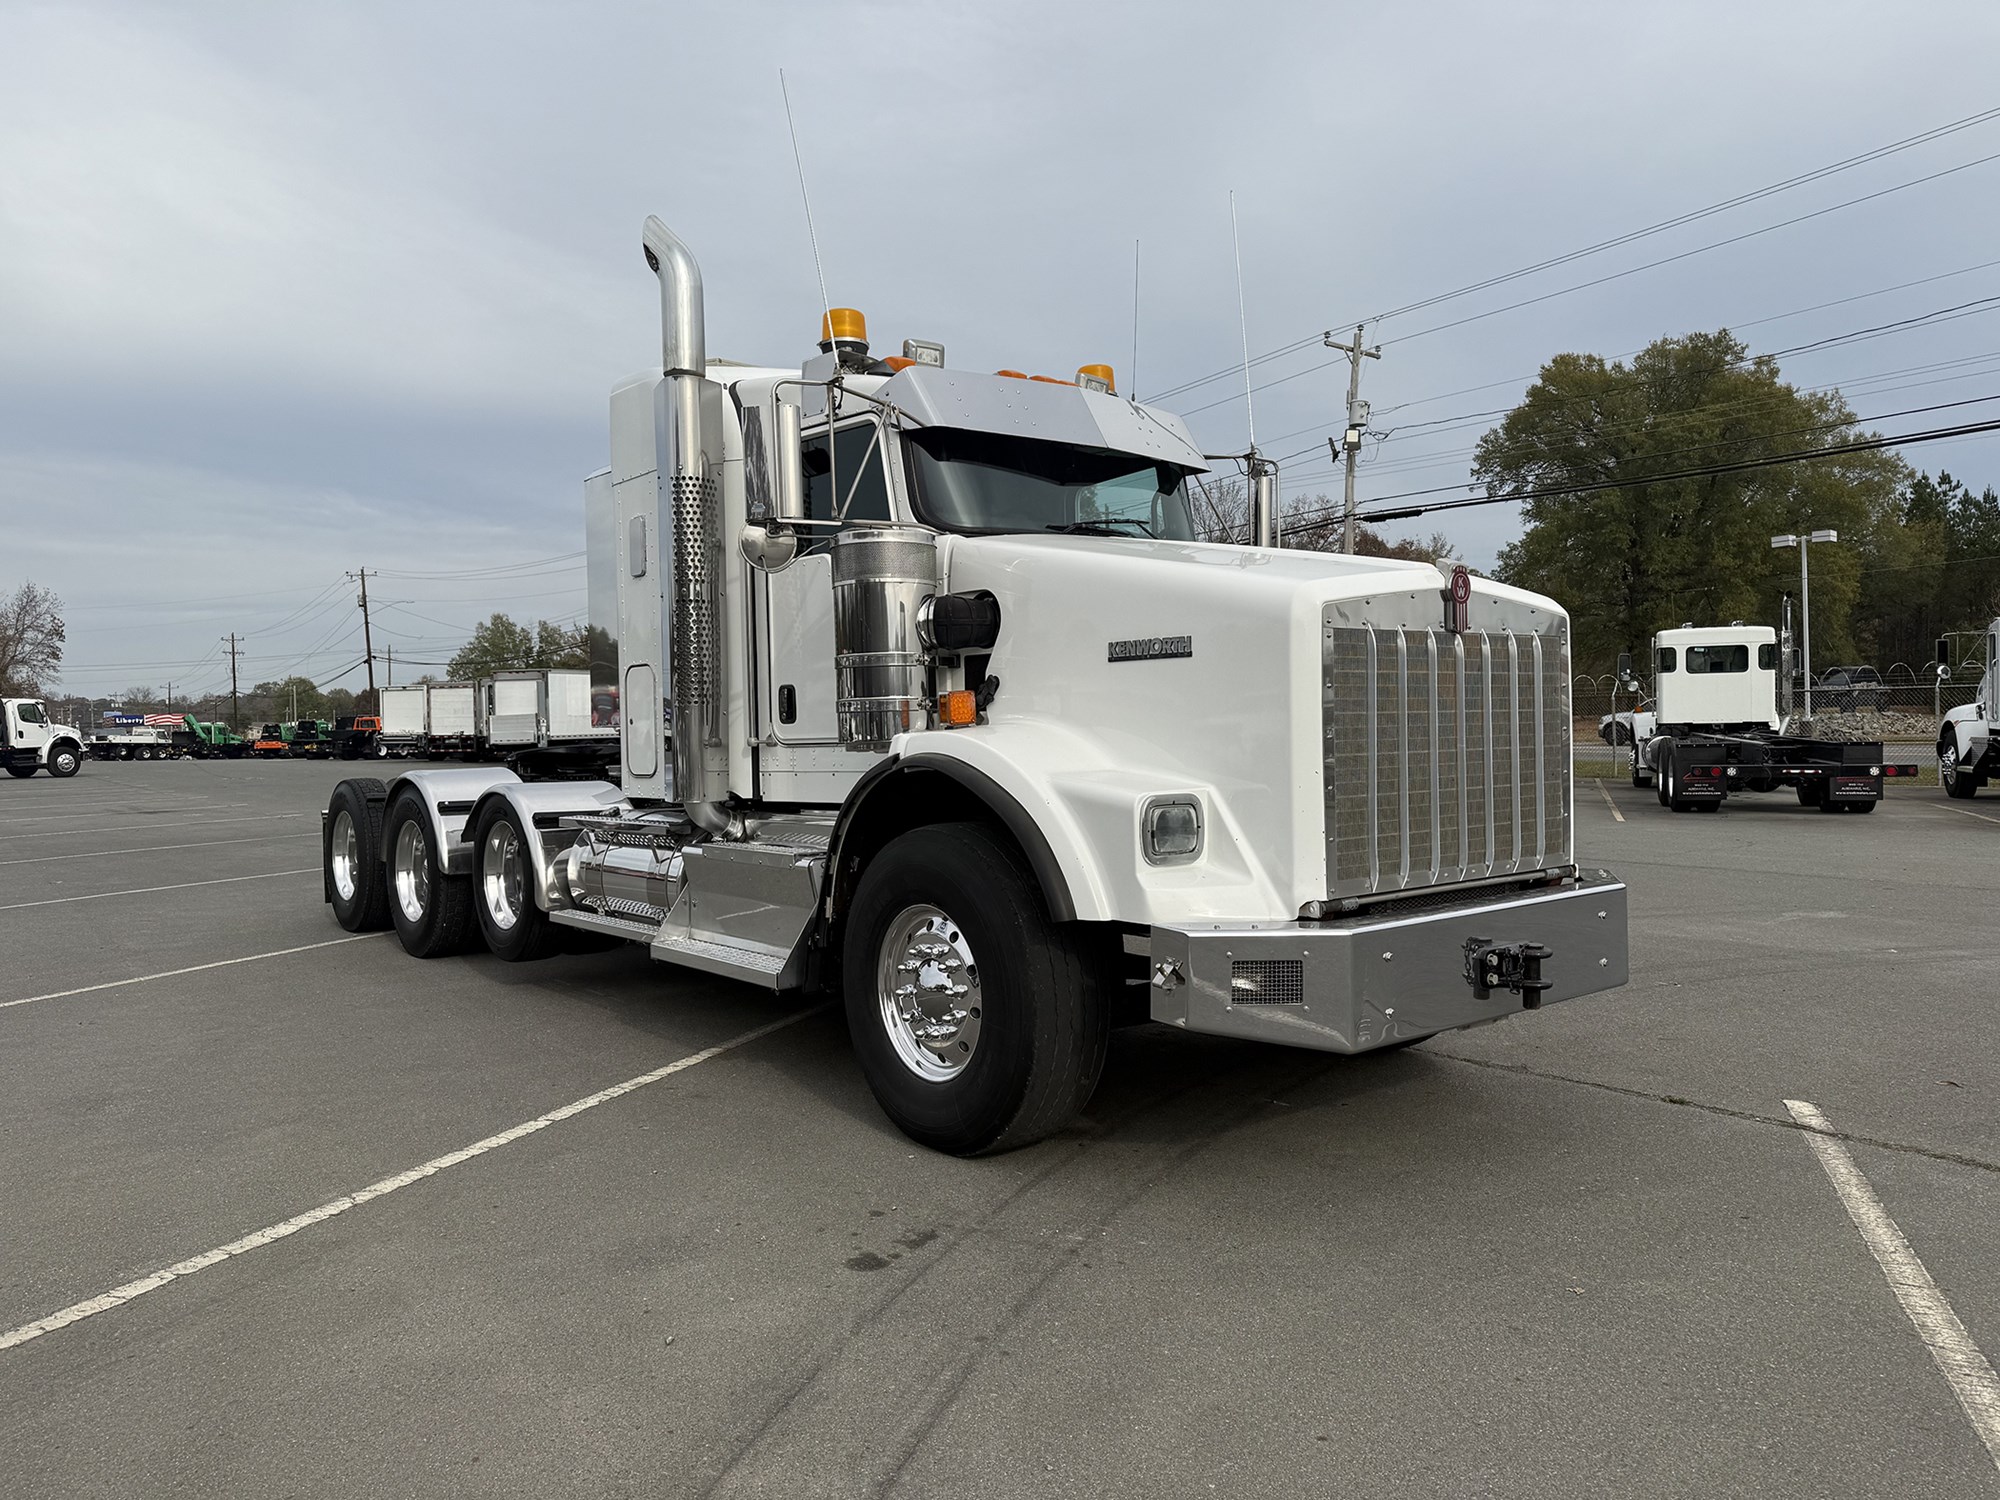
[926,534,1568,918]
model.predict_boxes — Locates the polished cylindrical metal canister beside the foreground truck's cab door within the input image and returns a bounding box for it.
[834,526,938,750]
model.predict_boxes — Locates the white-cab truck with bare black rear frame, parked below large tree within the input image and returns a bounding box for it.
[1618,620,1918,812]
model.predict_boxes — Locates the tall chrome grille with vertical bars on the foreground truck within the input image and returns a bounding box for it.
[1322,606,1572,896]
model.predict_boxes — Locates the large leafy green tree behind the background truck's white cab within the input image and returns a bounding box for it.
[1472,330,1908,670]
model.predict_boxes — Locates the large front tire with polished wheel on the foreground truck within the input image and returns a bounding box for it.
[842,824,1110,1156]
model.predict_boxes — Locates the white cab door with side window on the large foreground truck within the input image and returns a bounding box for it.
[758,416,894,748]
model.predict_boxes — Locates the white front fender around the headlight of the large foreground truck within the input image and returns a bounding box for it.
[894,722,1298,924]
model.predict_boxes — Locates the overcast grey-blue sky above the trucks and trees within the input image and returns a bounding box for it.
[0,0,2000,696]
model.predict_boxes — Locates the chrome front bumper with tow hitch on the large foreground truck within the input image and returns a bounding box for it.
[1132,870,1628,1052]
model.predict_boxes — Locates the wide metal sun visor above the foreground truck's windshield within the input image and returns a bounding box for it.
[880,366,1208,470]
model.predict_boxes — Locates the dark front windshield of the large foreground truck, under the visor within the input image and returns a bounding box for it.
[904,428,1194,542]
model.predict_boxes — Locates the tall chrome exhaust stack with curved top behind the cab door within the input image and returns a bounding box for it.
[642,216,742,836]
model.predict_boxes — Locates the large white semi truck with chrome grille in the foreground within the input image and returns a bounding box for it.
[324,220,1626,1154]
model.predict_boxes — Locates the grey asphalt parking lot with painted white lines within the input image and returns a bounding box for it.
[0,762,2000,1498]
